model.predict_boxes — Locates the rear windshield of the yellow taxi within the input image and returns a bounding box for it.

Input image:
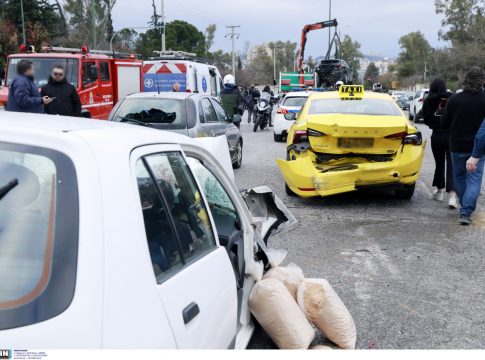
[308,98,402,116]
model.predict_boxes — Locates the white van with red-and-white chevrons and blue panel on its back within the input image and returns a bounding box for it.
[143,52,223,97]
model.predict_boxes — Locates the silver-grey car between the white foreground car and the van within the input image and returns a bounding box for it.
[108,92,243,169]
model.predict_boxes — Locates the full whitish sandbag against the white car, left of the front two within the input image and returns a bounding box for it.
[249,279,315,349]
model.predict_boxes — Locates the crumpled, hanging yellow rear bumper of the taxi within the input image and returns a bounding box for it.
[277,144,425,197]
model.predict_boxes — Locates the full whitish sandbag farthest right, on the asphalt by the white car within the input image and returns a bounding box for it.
[298,279,357,349]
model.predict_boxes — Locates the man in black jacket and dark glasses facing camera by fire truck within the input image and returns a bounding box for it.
[41,65,81,116]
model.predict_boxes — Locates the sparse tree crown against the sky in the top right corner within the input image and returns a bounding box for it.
[435,0,485,45]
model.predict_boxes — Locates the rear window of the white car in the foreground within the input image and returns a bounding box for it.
[0,142,78,330]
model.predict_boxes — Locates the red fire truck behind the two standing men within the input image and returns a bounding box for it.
[0,45,143,120]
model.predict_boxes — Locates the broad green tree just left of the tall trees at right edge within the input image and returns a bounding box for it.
[397,31,433,78]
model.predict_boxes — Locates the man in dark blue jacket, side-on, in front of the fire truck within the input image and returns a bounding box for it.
[6,60,52,113]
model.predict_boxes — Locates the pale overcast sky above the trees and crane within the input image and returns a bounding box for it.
[113,0,444,58]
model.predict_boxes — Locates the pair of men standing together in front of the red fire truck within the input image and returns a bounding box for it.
[6,60,81,116]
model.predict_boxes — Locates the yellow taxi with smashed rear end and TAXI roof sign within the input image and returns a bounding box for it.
[277,85,426,199]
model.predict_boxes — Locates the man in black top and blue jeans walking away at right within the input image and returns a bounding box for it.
[442,67,485,225]
